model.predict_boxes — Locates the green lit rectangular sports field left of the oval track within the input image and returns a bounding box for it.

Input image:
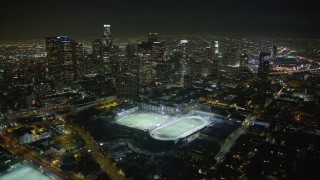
[117,113,168,130]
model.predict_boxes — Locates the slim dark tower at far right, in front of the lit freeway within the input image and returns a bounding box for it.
[258,52,270,82]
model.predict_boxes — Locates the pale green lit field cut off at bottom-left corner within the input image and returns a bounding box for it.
[0,166,50,180]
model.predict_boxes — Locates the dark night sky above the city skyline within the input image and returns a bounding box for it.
[0,0,320,39]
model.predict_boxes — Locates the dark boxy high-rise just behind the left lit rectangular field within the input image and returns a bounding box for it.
[116,73,139,100]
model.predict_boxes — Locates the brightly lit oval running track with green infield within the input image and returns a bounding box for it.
[150,116,207,140]
